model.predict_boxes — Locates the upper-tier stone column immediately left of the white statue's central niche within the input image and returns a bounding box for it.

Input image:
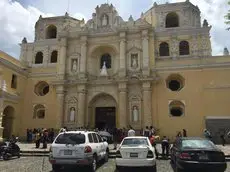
[79,36,87,78]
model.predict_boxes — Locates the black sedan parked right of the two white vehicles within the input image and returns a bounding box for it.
[171,137,227,172]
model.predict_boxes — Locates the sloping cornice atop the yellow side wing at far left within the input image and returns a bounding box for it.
[0,58,28,77]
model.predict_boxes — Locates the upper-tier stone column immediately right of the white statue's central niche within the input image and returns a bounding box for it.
[119,32,126,77]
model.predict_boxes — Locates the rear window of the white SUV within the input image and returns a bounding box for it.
[55,133,85,144]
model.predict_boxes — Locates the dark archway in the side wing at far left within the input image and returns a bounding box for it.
[2,106,14,139]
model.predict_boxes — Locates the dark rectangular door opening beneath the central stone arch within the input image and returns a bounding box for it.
[95,107,116,130]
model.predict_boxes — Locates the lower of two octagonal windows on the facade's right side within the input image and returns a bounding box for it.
[169,101,184,117]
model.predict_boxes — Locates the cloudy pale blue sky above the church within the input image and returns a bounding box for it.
[0,0,230,58]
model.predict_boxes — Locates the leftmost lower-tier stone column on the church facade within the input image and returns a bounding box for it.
[56,85,65,129]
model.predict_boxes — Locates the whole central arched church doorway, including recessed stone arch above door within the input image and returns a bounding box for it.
[88,94,117,130]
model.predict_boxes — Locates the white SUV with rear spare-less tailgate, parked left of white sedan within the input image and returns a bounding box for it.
[49,131,109,172]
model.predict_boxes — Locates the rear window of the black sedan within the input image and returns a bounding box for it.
[182,140,215,149]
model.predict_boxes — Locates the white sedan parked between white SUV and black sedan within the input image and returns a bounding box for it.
[116,137,156,172]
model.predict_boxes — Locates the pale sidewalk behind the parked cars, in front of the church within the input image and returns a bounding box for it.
[18,143,230,157]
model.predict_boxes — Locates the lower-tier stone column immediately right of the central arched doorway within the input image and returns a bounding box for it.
[118,83,128,128]
